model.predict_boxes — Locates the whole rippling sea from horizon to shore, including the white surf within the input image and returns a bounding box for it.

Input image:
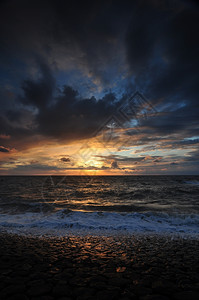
[0,175,199,237]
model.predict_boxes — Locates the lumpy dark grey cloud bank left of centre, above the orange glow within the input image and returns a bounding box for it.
[0,60,127,145]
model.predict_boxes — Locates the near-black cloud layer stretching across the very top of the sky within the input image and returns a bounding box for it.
[0,0,199,101]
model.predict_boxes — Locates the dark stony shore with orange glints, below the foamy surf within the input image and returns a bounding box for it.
[0,234,199,300]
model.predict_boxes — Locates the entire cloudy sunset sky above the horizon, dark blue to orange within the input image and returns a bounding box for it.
[0,0,199,175]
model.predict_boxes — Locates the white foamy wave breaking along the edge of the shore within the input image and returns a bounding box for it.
[0,210,199,236]
